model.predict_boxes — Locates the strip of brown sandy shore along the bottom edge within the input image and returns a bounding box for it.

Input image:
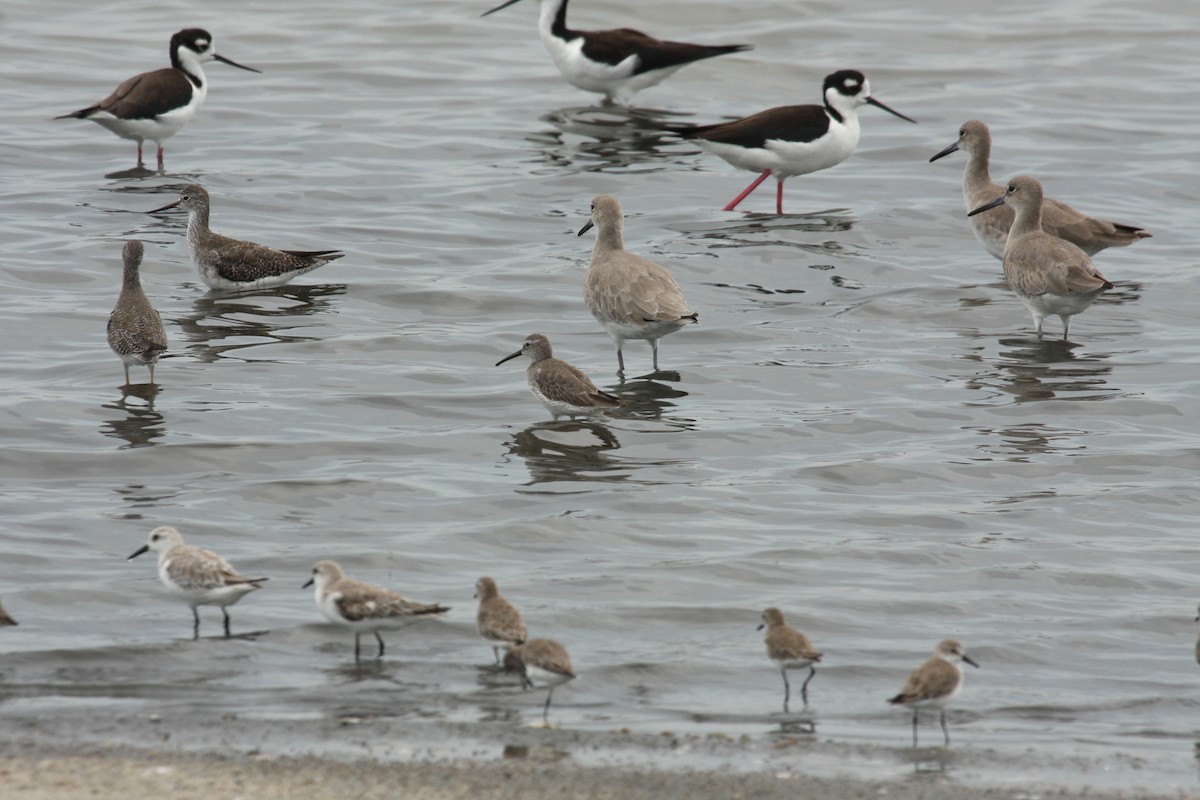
[0,744,1184,800]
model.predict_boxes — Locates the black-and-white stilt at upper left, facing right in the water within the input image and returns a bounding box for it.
[54,28,260,172]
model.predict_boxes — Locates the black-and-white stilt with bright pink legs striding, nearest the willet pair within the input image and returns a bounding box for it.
[670,70,917,213]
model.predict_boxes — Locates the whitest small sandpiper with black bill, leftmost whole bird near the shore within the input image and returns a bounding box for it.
[126,525,266,639]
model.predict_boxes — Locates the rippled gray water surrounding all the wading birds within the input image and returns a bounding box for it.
[0,0,1200,789]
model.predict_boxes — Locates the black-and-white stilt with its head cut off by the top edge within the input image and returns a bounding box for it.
[484,0,750,106]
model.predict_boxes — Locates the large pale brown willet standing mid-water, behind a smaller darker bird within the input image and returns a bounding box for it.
[578,194,700,377]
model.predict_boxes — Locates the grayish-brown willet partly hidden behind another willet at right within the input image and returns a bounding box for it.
[930,120,1150,260]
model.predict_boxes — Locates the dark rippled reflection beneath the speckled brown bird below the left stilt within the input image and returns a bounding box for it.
[173,283,346,363]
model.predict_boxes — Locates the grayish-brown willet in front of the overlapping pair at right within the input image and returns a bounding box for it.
[967,175,1112,342]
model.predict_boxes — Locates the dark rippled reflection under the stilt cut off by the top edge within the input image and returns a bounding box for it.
[529,106,683,173]
